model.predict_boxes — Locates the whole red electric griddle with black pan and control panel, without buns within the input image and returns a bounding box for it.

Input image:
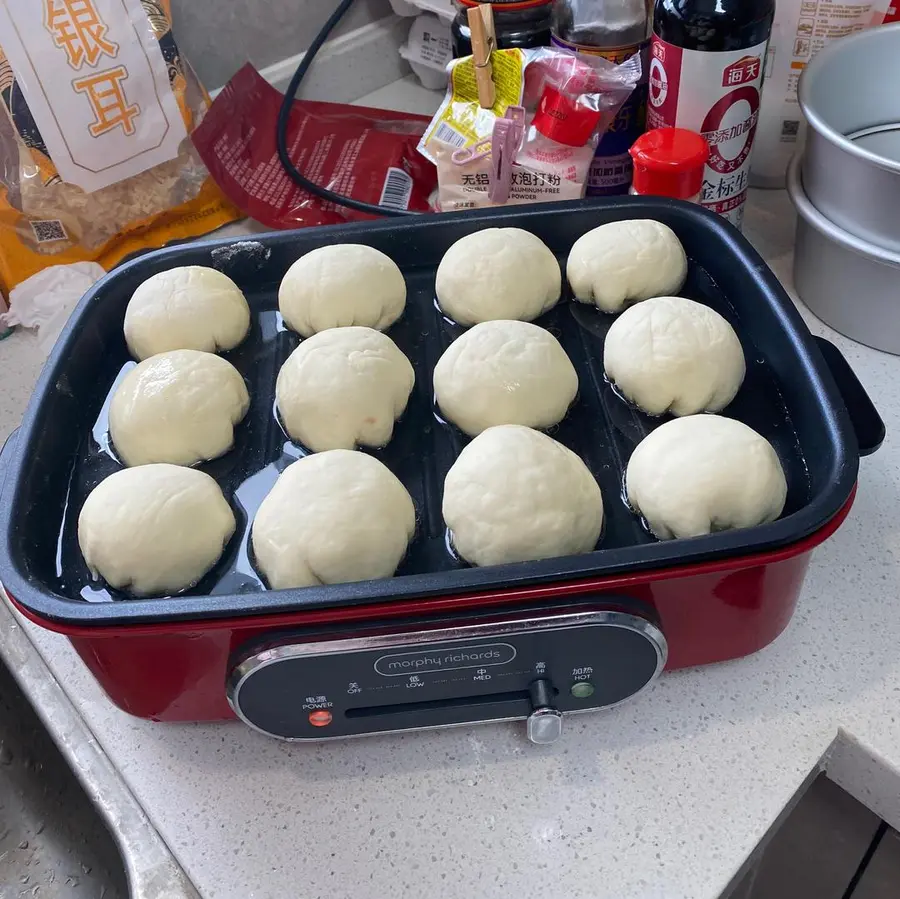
[0,198,884,742]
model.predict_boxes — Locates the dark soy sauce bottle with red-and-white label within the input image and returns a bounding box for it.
[647,0,775,227]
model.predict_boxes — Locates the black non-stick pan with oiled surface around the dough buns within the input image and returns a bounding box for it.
[0,198,858,624]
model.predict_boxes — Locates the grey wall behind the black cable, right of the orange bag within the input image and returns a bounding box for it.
[172,0,391,90]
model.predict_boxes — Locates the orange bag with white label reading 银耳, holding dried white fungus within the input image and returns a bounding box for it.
[0,0,238,292]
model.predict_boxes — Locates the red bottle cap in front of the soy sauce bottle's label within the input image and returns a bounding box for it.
[628,128,709,200]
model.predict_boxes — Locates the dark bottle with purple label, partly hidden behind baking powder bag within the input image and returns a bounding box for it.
[551,0,650,197]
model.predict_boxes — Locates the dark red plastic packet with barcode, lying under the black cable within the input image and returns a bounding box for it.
[194,63,437,228]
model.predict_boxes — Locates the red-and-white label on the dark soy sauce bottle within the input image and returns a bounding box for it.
[647,35,766,227]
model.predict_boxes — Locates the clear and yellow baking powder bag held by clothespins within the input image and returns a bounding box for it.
[419,48,641,211]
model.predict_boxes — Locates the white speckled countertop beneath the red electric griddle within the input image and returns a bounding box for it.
[0,77,900,899]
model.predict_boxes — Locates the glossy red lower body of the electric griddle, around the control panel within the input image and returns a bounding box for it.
[11,500,855,721]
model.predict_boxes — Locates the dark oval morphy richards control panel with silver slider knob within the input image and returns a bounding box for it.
[227,609,666,743]
